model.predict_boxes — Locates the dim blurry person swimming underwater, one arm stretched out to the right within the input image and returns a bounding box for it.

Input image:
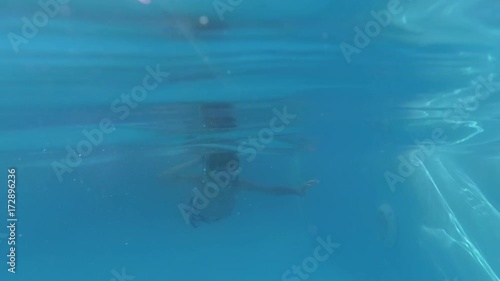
[168,151,319,227]
